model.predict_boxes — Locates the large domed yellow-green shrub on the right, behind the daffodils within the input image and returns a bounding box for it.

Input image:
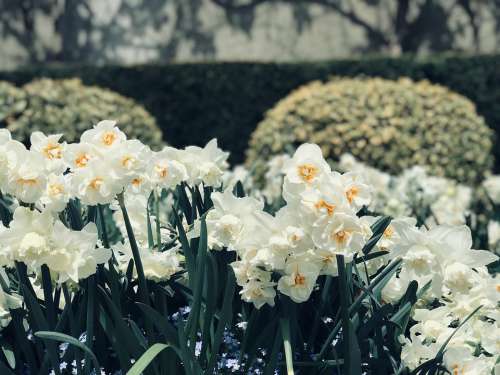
[247,78,493,184]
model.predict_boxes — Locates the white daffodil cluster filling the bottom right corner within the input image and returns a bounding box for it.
[382,226,500,375]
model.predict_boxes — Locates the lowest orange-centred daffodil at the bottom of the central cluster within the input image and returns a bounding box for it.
[278,256,320,303]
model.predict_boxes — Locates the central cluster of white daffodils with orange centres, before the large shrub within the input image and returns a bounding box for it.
[207,144,372,307]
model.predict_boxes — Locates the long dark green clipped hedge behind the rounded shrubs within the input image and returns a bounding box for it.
[0,55,500,164]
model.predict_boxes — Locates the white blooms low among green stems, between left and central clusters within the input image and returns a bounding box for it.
[113,241,184,282]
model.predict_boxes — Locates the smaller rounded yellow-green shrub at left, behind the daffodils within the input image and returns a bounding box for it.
[7,78,163,149]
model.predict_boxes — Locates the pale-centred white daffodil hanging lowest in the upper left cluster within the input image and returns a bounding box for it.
[39,173,72,212]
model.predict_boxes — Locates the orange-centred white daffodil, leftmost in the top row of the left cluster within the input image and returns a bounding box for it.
[30,132,66,174]
